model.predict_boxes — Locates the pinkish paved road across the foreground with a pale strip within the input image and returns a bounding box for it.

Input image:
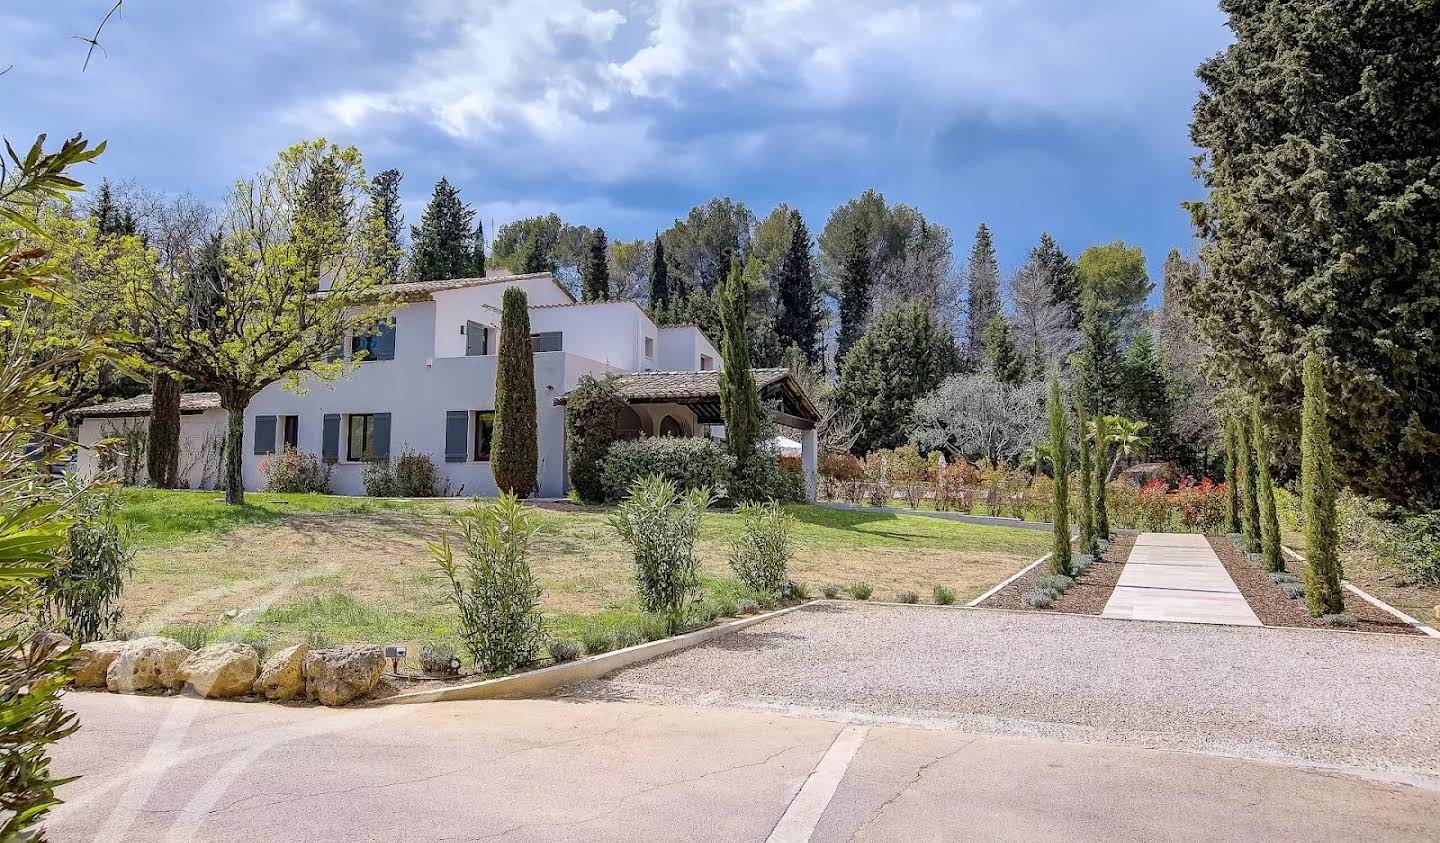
[48,683,1440,843]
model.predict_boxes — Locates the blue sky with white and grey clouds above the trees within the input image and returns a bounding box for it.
[0,0,1228,295]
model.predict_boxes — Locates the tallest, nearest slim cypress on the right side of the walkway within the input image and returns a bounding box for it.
[1300,352,1345,615]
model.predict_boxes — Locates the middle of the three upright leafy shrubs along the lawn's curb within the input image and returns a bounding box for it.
[609,476,714,634]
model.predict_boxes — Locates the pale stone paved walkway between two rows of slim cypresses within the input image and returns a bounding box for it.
[1100,533,1260,627]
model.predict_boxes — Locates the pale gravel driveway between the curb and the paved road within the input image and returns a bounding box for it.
[562,602,1440,788]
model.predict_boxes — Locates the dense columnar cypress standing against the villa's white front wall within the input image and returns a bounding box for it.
[490,287,540,497]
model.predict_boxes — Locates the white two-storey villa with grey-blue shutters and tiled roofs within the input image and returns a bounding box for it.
[72,272,818,497]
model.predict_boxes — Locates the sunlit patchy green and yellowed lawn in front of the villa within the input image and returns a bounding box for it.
[122,490,1048,657]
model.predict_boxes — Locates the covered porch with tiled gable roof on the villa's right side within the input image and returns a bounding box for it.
[554,369,819,500]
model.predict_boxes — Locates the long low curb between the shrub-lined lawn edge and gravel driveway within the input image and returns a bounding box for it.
[361,601,816,708]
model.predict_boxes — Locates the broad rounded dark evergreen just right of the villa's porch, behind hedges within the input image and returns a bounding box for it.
[837,303,960,454]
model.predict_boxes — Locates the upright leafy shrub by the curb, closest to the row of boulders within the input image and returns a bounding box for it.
[431,493,544,673]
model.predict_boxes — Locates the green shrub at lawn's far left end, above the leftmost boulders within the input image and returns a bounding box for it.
[40,493,135,644]
